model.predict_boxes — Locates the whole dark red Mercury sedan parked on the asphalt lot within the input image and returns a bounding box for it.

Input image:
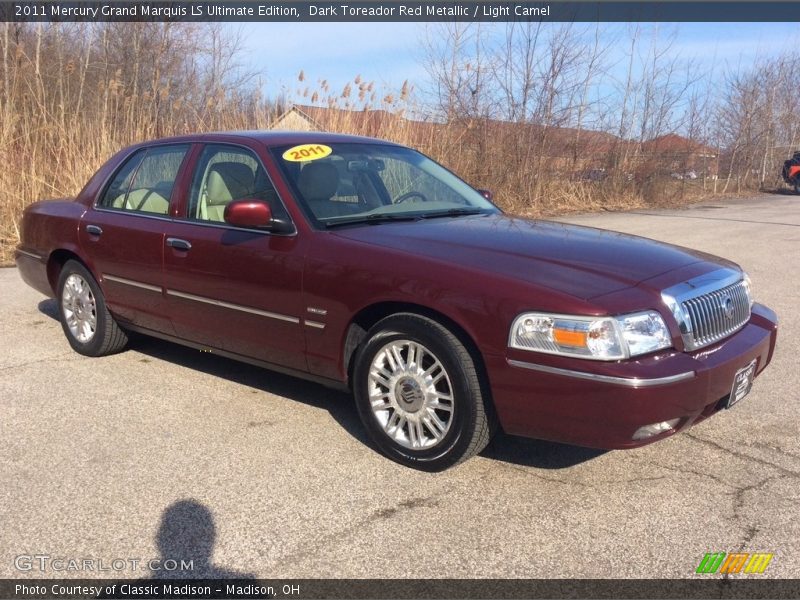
[16,132,777,470]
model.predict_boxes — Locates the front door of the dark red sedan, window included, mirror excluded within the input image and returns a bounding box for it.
[164,144,306,370]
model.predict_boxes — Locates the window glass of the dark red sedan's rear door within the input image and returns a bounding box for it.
[100,145,189,215]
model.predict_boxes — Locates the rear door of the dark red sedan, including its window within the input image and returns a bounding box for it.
[79,144,191,333]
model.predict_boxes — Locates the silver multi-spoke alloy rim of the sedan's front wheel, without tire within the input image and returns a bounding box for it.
[367,340,453,450]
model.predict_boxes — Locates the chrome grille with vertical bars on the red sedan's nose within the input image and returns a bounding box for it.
[681,281,750,348]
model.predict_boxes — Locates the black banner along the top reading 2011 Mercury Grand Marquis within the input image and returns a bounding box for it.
[0,0,800,23]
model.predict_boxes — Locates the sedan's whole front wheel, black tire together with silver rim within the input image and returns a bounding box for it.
[353,313,494,471]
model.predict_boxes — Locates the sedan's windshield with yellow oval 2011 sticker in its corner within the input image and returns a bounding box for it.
[273,143,499,227]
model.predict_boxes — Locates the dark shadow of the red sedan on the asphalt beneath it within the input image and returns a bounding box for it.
[38,298,606,469]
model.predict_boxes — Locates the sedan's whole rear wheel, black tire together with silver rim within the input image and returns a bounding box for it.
[56,260,128,356]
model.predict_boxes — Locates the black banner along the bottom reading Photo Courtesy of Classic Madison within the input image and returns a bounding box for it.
[0,576,800,600]
